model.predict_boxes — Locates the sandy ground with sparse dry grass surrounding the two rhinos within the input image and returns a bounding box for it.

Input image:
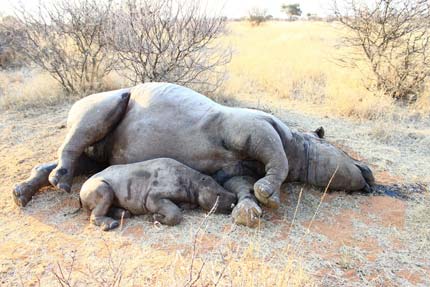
[0,99,430,286]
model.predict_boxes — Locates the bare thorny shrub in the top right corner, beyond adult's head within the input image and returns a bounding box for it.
[334,0,430,102]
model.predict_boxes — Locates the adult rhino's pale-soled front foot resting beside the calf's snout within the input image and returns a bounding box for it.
[231,198,263,227]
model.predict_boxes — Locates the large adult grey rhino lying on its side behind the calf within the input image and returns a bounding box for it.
[13,83,373,225]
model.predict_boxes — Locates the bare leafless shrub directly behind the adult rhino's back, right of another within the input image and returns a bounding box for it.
[111,0,230,92]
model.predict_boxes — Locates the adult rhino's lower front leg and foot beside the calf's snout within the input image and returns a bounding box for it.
[224,176,263,227]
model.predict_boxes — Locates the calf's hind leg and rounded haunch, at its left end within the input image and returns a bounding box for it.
[80,179,119,231]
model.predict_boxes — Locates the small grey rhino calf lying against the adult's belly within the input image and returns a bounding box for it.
[80,158,237,231]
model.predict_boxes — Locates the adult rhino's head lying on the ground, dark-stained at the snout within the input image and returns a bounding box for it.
[286,127,374,192]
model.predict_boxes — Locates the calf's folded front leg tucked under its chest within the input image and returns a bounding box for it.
[147,198,182,225]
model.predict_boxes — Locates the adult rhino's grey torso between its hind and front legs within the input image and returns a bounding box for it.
[110,83,239,172]
